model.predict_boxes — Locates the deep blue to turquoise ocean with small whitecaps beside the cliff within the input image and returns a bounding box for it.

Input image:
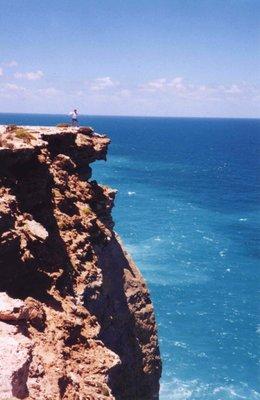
[0,114,260,400]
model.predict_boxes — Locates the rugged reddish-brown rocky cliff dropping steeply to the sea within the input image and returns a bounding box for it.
[0,126,161,400]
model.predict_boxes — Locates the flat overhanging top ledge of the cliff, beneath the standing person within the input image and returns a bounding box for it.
[0,124,110,171]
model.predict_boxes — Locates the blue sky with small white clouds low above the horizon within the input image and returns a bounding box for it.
[0,0,260,118]
